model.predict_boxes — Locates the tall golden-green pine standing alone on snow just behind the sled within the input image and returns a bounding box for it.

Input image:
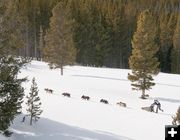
[128,10,159,98]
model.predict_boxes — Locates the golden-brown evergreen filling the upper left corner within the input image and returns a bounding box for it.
[0,0,24,55]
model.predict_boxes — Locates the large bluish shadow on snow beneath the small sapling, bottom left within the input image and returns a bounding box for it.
[11,115,132,140]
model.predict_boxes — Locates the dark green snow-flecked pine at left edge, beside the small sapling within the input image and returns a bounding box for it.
[0,56,25,136]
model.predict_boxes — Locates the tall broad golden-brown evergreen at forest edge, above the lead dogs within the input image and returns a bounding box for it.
[44,2,76,75]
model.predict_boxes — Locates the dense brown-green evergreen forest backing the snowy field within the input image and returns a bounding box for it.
[0,0,180,74]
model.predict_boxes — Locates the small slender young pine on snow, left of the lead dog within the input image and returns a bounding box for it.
[26,78,42,125]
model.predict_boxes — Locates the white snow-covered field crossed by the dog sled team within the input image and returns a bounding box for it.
[0,61,180,140]
